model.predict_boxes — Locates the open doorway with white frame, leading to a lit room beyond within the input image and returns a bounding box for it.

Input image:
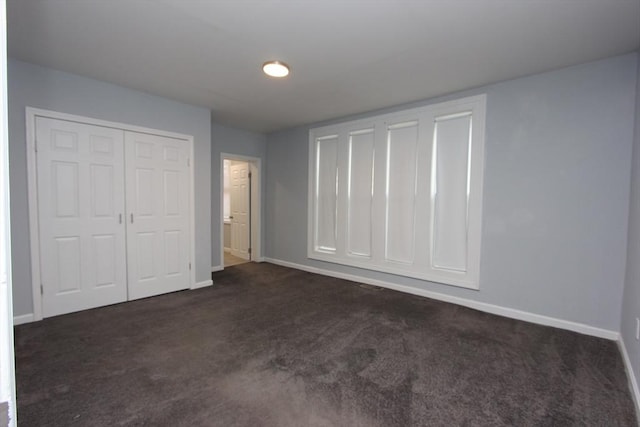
[220,153,261,269]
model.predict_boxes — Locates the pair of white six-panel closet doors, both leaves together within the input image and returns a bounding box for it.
[36,117,190,317]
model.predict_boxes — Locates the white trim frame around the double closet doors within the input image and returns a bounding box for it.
[25,107,196,321]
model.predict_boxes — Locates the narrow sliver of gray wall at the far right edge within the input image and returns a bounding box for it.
[620,52,640,390]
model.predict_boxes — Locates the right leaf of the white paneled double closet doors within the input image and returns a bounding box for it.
[125,132,190,300]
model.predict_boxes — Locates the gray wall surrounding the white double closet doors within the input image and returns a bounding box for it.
[8,59,211,316]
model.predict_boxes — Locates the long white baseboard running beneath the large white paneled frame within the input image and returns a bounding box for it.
[265,257,620,341]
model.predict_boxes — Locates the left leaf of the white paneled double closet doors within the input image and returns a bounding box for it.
[36,117,127,317]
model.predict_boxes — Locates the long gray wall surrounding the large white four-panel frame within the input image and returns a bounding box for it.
[266,54,637,331]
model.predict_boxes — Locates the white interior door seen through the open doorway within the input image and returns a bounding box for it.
[229,162,250,259]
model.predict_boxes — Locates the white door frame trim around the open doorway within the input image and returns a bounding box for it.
[219,153,264,271]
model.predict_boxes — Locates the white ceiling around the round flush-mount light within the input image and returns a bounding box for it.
[7,0,640,132]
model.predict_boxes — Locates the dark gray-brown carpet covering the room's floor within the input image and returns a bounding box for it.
[16,264,636,427]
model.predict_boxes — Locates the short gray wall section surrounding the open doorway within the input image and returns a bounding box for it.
[210,122,267,267]
